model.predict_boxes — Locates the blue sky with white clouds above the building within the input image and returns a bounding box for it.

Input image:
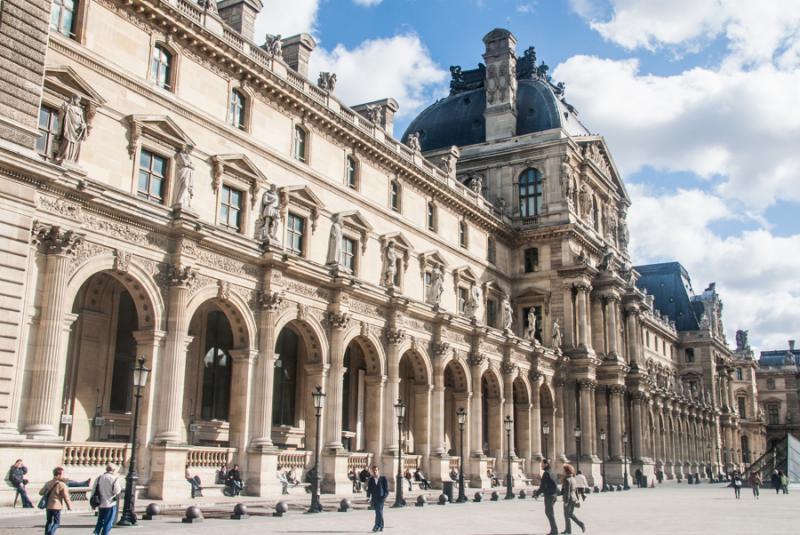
[257,0,800,356]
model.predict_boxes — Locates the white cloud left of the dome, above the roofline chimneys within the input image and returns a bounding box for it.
[311,34,447,123]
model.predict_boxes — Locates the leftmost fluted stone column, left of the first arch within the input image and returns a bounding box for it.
[24,223,83,438]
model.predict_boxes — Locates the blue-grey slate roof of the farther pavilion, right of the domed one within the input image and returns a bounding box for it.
[634,262,703,331]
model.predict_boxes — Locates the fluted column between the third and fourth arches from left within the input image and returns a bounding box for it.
[325,312,350,450]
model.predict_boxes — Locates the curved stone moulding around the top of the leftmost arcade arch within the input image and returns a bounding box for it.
[65,253,166,330]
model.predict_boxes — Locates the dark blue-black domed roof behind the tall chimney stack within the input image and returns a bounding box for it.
[403,71,589,151]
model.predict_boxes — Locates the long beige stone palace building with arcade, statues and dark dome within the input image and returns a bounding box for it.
[0,0,752,501]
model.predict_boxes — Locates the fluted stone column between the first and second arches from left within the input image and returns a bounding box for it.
[155,266,196,444]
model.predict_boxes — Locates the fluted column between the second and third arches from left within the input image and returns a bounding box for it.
[252,293,283,449]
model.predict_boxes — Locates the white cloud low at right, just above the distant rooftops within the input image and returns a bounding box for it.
[629,185,800,349]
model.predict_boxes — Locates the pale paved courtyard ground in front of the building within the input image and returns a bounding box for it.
[0,484,800,535]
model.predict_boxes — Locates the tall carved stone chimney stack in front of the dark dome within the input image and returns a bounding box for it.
[483,28,517,141]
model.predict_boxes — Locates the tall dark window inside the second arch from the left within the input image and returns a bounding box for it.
[202,310,233,420]
